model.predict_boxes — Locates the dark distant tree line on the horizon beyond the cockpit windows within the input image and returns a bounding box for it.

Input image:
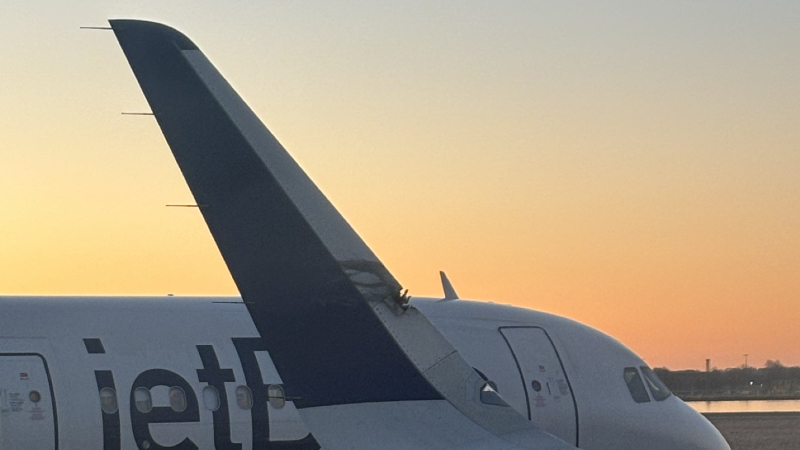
[655,360,800,401]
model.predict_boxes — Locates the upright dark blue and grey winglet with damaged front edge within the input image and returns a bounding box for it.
[110,20,572,448]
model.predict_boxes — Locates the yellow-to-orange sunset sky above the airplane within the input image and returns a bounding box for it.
[0,0,800,368]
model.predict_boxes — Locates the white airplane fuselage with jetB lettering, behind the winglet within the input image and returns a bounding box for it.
[0,297,725,450]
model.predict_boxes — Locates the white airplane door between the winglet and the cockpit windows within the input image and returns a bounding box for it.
[500,327,578,445]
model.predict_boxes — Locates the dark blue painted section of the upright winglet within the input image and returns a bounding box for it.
[111,20,442,408]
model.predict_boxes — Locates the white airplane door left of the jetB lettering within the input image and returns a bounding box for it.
[0,354,56,450]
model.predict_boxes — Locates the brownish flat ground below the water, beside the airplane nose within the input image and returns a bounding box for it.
[705,412,800,450]
